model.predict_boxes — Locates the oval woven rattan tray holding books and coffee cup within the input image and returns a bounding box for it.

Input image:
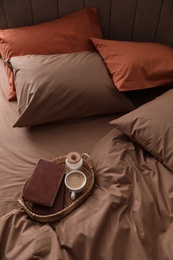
[19,153,95,223]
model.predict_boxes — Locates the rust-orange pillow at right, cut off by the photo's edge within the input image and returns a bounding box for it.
[91,38,173,91]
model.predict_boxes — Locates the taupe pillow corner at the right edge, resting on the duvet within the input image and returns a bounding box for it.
[110,89,173,172]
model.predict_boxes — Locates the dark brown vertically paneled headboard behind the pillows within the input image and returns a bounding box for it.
[0,0,173,46]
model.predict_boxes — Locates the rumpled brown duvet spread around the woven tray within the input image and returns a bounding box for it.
[0,121,173,260]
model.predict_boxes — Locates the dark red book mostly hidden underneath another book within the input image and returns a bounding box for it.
[32,181,65,215]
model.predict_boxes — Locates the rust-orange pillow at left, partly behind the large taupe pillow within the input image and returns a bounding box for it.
[0,8,102,100]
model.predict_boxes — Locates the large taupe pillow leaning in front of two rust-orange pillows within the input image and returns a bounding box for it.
[9,51,134,127]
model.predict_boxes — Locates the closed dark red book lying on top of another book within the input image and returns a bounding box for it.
[23,159,65,207]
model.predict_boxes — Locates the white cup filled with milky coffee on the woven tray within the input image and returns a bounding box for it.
[64,170,87,200]
